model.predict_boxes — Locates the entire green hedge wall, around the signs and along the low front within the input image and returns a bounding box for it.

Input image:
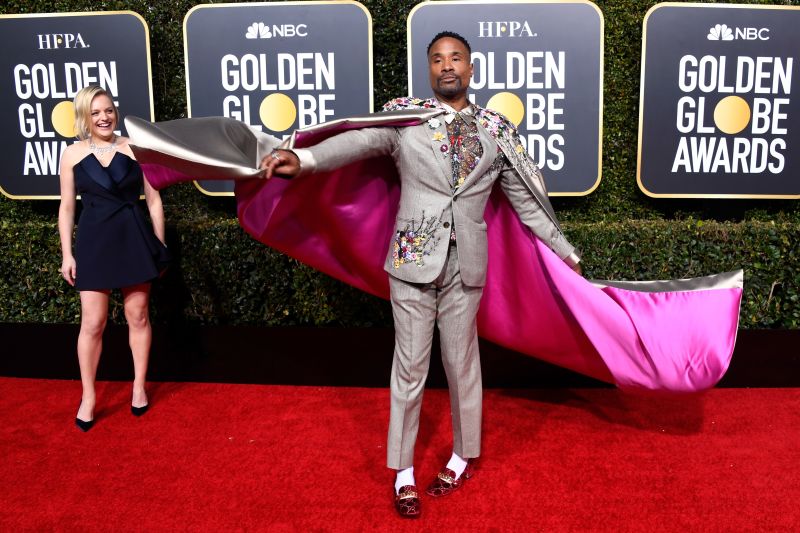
[0,0,800,328]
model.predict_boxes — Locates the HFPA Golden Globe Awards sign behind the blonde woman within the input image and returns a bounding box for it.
[0,11,153,199]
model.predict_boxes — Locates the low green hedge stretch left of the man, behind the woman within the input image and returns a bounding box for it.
[0,215,391,326]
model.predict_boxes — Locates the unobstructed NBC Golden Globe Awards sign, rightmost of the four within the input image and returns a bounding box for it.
[638,4,800,198]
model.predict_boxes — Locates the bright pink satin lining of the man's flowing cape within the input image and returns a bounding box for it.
[137,121,742,393]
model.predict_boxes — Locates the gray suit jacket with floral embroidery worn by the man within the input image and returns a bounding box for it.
[294,110,577,287]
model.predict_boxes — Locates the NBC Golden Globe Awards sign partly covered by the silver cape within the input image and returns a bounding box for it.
[184,1,372,195]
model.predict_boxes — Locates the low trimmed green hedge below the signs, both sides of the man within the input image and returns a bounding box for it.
[0,214,800,328]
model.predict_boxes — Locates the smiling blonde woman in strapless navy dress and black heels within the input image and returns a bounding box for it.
[58,86,168,431]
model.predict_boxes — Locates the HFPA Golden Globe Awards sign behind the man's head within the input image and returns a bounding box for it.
[408,0,603,196]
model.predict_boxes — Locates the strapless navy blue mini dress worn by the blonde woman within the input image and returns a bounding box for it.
[73,152,169,290]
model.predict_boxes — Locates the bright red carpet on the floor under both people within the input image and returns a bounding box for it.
[0,378,800,532]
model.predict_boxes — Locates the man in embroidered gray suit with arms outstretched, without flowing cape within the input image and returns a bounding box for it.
[261,32,580,518]
